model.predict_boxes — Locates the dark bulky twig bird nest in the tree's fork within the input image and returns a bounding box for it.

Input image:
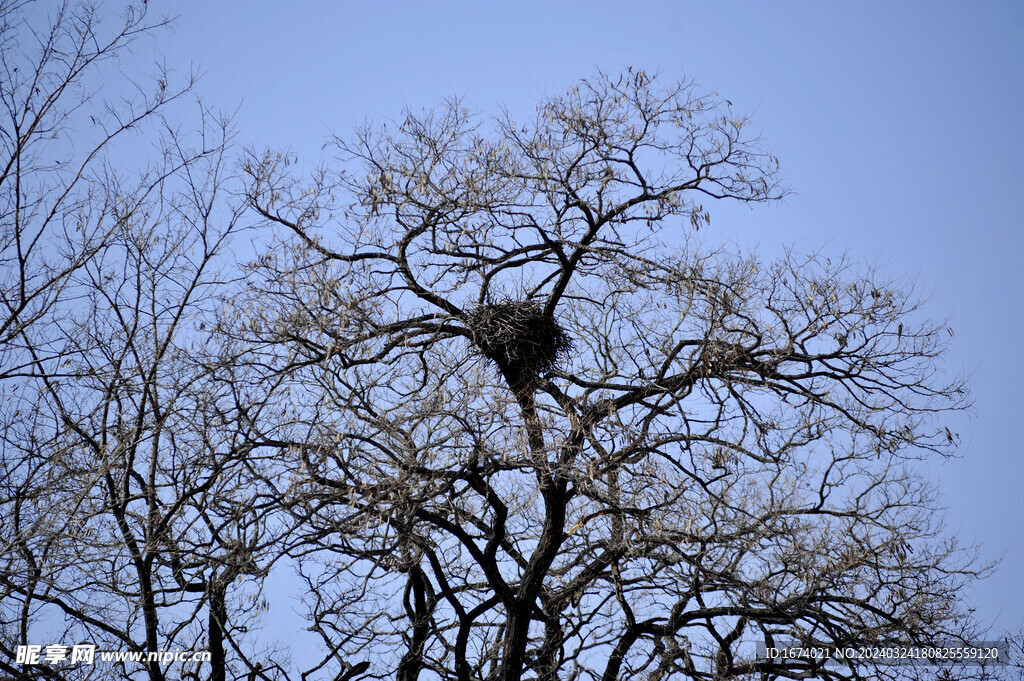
[467,301,572,391]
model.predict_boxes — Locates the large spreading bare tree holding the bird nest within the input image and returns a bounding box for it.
[233,71,980,681]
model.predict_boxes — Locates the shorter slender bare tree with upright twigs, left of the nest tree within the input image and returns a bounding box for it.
[0,102,292,680]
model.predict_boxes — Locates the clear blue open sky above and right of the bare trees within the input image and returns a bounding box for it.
[136,0,1024,659]
